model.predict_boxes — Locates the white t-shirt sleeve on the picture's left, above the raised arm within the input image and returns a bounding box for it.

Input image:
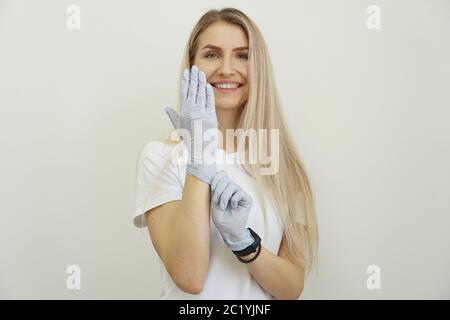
[133,141,184,228]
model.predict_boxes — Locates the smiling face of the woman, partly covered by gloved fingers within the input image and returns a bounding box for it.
[194,21,248,109]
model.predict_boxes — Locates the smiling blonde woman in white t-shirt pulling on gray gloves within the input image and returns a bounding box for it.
[134,8,318,299]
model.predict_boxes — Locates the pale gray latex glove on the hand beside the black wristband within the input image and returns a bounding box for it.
[211,171,254,251]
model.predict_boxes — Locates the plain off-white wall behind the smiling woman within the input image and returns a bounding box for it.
[0,0,450,299]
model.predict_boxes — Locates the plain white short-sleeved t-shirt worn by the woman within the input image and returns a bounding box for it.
[134,141,283,300]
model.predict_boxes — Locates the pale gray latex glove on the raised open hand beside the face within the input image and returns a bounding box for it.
[166,65,218,184]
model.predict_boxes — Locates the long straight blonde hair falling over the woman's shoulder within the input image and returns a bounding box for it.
[164,8,319,274]
